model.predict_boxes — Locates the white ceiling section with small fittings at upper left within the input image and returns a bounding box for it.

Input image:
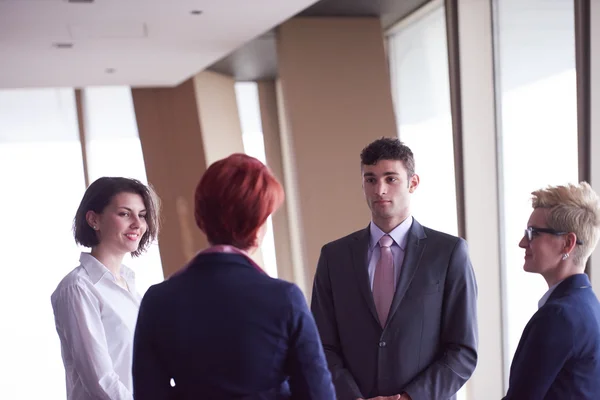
[0,0,322,88]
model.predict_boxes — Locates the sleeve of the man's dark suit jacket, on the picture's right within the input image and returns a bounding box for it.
[405,239,477,400]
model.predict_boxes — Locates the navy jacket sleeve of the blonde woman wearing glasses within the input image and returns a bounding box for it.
[505,304,574,400]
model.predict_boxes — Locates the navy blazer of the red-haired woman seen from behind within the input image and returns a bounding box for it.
[133,253,335,400]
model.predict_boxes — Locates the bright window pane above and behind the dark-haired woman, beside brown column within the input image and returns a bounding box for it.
[83,86,163,295]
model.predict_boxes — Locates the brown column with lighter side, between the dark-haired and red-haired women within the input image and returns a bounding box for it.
[132,72,248,277]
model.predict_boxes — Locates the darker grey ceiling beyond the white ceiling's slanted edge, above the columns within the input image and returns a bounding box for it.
[210,0,430,81]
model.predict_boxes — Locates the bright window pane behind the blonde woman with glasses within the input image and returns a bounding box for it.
[495,0,578,367]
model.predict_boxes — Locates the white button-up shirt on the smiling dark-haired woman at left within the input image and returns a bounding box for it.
[51,253,141,400]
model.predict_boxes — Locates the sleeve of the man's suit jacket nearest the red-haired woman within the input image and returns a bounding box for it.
[311,246,363,400]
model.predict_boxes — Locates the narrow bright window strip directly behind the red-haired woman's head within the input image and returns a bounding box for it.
[235,82,277,278]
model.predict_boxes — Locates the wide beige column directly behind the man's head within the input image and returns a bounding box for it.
[277,18,396,296]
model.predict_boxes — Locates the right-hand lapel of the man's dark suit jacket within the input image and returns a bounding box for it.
[386,219,427,326]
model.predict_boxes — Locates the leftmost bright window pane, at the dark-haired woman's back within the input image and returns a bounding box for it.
[0,89,85,400]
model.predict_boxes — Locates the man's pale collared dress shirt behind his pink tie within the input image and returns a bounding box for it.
[367,216,413,290]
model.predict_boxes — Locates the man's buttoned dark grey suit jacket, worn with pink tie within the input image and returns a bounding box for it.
[311,220,477,400]
